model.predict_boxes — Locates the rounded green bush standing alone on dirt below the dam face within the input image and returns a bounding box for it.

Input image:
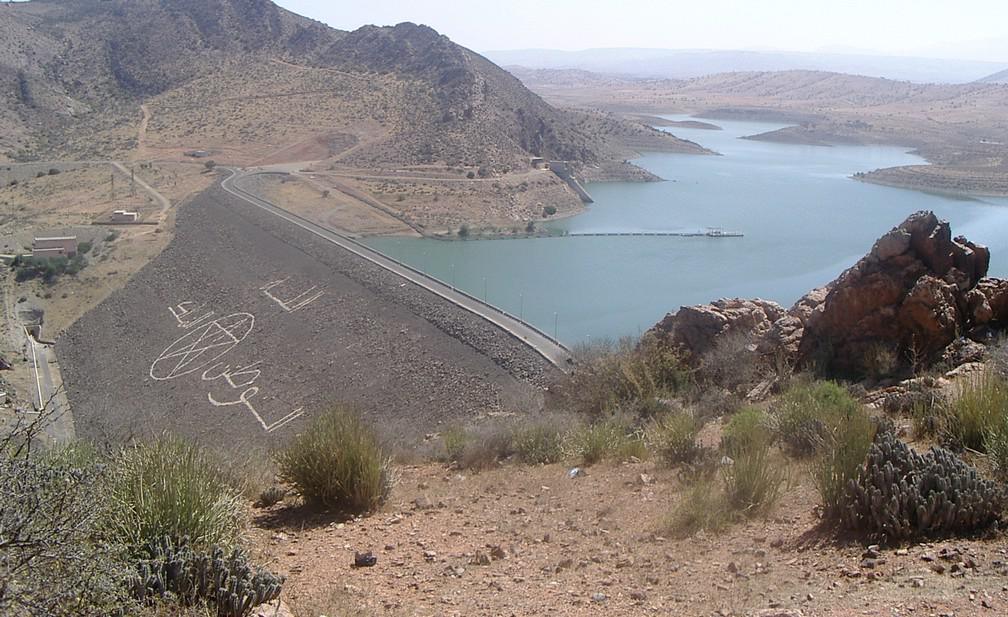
[276,406,391,512]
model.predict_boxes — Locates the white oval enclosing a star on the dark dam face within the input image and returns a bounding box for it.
[150,312,255,381]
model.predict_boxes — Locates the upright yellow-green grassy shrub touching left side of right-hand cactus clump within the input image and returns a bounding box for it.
[811,406,876,517]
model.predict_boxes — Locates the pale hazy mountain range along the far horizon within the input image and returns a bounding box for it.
[485,48,1005,84]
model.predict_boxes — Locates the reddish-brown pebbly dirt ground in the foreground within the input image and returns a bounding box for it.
[253,462,1008,617]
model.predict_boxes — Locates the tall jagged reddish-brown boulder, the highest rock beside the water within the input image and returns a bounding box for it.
[798,212,995,373]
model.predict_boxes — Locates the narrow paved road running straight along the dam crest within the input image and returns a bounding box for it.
[221,169,573,370]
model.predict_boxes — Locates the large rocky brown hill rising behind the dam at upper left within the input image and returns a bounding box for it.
[0,0,701,169]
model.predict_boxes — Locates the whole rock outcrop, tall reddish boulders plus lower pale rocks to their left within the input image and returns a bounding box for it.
[650,212,1008,375]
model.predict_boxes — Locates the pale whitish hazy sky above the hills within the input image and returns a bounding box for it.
[277,0,1008,61]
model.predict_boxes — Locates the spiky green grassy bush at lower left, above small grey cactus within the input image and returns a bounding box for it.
[107,437,243,550]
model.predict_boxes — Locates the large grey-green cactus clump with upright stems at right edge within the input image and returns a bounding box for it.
[840,431,1008,541]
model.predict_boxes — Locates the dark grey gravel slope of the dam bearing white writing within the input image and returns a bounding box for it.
[57,189,549,444]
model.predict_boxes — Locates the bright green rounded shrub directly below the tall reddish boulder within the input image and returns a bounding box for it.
[770,381,861,456]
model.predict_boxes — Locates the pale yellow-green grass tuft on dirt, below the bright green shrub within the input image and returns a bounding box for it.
[721,441,786,516]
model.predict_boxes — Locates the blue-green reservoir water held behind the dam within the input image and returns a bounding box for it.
[366,116,1008,343]
